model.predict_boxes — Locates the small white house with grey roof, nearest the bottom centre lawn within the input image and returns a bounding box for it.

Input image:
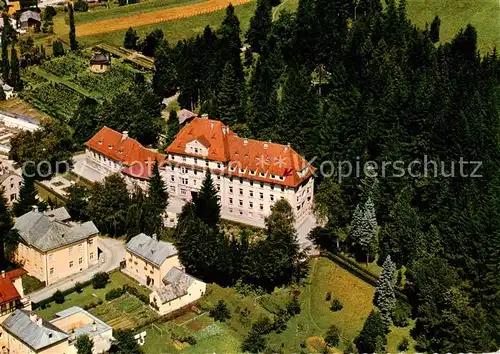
[149,267,207,315]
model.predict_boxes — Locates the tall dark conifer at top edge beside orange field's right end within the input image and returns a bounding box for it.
[246,0,272,53]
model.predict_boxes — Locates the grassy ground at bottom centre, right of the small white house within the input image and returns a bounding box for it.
[138,258,409,354]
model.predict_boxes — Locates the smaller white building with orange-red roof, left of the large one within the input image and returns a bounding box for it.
[83,127,165,189]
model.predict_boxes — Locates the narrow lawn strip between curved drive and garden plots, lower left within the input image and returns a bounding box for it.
[37,272,149,320]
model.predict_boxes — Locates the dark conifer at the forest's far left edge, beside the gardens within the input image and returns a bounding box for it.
[153,41,178,97]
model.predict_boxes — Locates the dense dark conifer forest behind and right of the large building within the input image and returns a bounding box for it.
[148,0,500,352]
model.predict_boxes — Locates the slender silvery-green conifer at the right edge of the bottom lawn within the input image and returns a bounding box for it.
[374,256,397,327]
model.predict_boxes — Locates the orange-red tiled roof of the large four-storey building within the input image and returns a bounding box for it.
[167,118,314,187]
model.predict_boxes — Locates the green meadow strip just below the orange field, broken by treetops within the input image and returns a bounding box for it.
[77,2,256,46]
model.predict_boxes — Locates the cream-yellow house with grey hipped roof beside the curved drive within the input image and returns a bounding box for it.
[14,207,99,285]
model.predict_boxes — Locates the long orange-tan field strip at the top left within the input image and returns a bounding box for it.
[76,0,254,37]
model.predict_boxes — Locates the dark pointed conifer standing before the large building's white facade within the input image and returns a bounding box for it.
[193,169,220,230]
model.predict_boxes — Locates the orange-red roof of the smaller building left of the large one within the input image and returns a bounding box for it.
[85,127,165,166]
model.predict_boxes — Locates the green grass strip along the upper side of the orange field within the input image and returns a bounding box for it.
[73,0,206,25]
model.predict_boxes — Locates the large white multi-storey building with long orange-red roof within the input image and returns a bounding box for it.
[163,118,314,226]
